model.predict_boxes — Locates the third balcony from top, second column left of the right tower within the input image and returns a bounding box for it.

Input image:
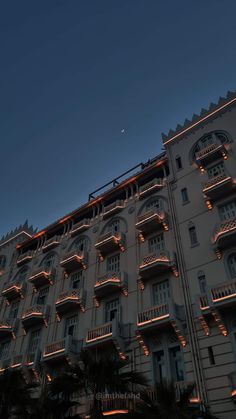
[94,272,128,299]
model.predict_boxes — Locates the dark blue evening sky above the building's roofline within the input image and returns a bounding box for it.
[0,0,236,235]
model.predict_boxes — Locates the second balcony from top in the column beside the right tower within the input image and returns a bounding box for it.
[135,209,169,235]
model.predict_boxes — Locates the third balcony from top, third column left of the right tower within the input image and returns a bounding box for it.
[55,289,86,318]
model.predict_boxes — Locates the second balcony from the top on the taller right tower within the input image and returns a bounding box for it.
[203,174,235,201]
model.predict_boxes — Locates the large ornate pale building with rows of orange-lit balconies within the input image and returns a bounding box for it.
[0,92,236,419]
